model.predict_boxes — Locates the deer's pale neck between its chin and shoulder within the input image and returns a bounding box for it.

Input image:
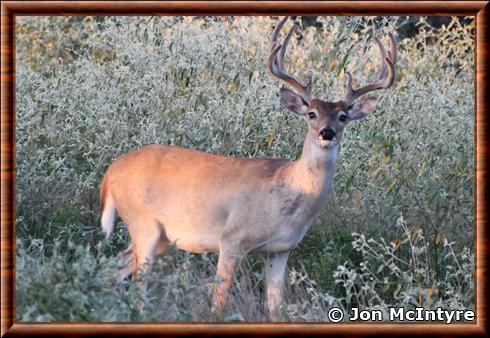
[288,136,337,197]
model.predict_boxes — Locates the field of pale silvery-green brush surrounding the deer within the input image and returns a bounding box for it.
[16,17,474,321]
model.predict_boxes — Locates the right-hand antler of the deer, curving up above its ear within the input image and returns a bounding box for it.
[343,33,398,105]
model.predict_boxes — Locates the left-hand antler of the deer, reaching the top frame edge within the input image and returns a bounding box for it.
[268,16,311,98]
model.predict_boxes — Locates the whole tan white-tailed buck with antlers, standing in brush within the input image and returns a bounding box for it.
[100,17,397,320]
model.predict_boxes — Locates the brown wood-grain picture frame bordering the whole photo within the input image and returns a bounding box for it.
[1,1,490,337]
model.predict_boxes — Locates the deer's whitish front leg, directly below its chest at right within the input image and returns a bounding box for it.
[265,252,289,321]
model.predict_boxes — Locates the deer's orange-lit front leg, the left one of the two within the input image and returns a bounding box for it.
[211,248,243,312]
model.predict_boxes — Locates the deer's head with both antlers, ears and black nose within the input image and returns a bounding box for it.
[268,17,397,148]
